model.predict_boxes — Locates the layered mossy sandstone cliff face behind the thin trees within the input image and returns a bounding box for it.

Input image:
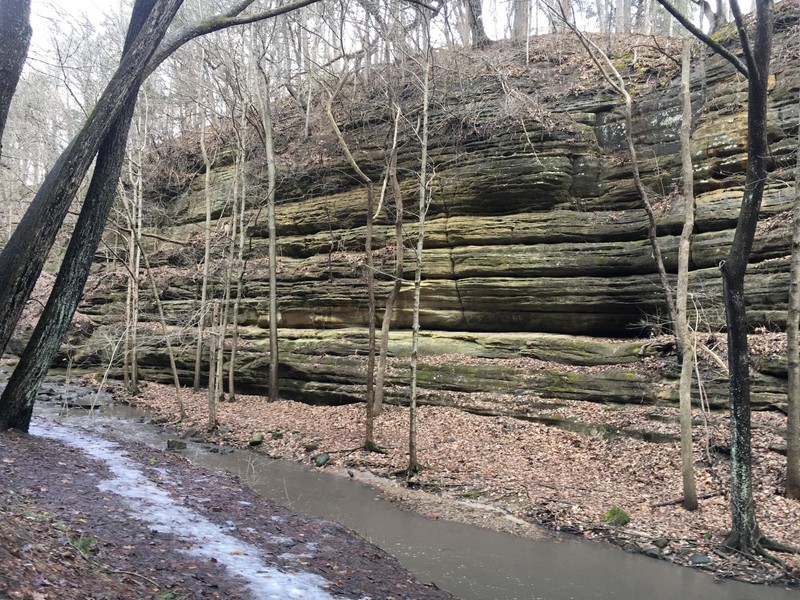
[76,11,800,418]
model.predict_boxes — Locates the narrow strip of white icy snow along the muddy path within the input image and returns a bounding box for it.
[31,421,335,600]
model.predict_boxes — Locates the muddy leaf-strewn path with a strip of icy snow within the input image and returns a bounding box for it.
[0,421,452,600]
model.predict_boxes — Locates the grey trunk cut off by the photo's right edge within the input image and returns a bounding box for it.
[786,83,800,500]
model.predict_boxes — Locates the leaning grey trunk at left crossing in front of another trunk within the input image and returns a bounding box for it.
[0,0,183,354]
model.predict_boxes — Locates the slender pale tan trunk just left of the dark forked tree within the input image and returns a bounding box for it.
[675,38,697,510]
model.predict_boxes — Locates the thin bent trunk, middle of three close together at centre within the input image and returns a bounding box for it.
[372,105,405,416]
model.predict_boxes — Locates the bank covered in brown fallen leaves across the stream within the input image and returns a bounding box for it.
[130,384,800,585]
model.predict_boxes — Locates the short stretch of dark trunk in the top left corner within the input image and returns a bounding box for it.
[0,0,33,157]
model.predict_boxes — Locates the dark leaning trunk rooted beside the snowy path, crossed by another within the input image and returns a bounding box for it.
[0,0,170,431]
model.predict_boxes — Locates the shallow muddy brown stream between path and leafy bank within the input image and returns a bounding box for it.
[29,402,800,600]
